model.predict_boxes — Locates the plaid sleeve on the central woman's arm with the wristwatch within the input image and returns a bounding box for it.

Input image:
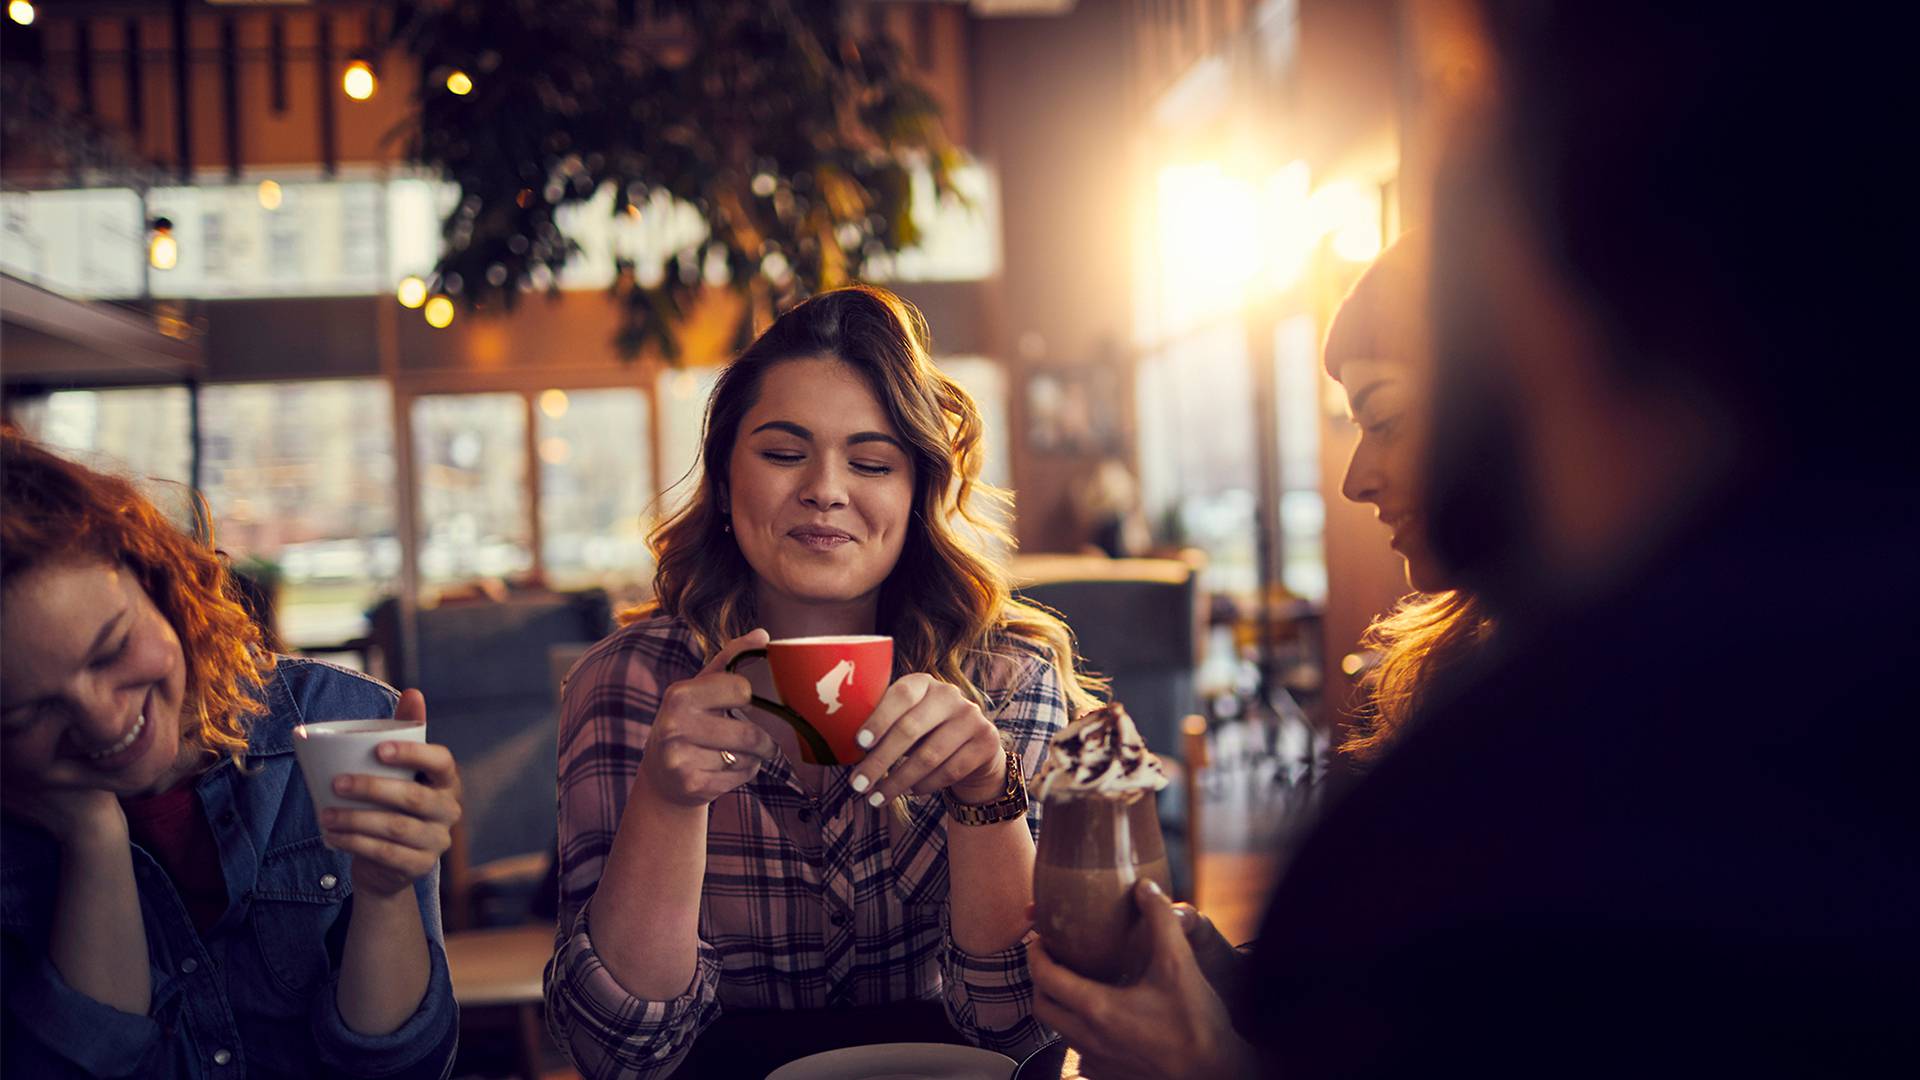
[941,645,1068,1061]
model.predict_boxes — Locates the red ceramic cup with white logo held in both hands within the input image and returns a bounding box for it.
[726,634,893,765]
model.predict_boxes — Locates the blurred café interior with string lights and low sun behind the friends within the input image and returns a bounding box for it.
[0,0,1476,1074]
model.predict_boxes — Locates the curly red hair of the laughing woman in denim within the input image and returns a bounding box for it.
[0,427,275,761]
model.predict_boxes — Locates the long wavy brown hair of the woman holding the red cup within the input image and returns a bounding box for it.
[637,284,1104,715]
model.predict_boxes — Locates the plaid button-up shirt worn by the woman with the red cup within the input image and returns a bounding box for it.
[547,617,1068,1080]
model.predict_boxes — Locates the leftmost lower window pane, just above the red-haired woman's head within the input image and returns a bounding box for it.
[12,386,194,484]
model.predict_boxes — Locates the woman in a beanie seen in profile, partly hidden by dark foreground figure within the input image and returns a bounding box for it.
[1325,234,1492,761]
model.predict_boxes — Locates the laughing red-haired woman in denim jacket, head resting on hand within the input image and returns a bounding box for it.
[0,429,461,1078]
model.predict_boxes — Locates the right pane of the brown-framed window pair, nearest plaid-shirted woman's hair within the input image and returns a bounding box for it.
[534,388,653,588]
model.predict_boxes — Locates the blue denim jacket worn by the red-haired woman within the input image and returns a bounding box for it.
[0,657,459,1080]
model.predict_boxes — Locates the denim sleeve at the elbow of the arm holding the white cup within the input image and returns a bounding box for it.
[311,867,459,1080]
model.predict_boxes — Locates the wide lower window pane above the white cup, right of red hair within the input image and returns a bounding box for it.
[202,379,399,650]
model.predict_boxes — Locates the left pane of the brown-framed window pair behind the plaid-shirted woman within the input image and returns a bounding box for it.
[413,394,534,584]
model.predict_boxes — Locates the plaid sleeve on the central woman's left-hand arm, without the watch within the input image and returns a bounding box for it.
[547,638,720,1080]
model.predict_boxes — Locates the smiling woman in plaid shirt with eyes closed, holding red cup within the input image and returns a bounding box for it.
[547,288,1094,1078]
